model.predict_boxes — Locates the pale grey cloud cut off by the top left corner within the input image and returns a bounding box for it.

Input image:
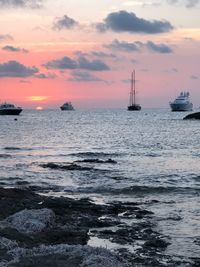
[0,0,43,8]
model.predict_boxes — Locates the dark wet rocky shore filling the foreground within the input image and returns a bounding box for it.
[0,188,195,267]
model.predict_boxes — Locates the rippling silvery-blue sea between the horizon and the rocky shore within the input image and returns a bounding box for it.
[0,109,200,258]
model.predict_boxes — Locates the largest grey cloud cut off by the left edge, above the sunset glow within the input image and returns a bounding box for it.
[0,60,39,78]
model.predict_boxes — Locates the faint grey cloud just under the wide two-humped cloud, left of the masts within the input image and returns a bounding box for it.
[69,71,103,82]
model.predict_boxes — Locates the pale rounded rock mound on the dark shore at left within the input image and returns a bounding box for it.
[0,208,55,234]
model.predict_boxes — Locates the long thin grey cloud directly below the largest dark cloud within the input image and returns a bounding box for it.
[105,39,173,54]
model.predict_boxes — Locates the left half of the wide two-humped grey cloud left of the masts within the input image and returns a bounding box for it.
[44,57,78,70]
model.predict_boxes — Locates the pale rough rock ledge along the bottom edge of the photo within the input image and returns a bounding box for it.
[10,244,127,267]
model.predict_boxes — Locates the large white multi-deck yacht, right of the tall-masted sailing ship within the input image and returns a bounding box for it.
[169,92,193,111]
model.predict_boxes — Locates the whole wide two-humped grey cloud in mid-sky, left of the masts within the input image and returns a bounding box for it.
[44,56,110,71]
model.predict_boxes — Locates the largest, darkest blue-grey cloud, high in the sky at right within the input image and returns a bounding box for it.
[96,10,173,34]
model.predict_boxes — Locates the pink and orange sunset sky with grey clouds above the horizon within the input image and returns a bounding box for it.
[0,0,200,109]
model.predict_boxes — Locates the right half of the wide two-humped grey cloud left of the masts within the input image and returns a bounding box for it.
[78,57,110,71]
